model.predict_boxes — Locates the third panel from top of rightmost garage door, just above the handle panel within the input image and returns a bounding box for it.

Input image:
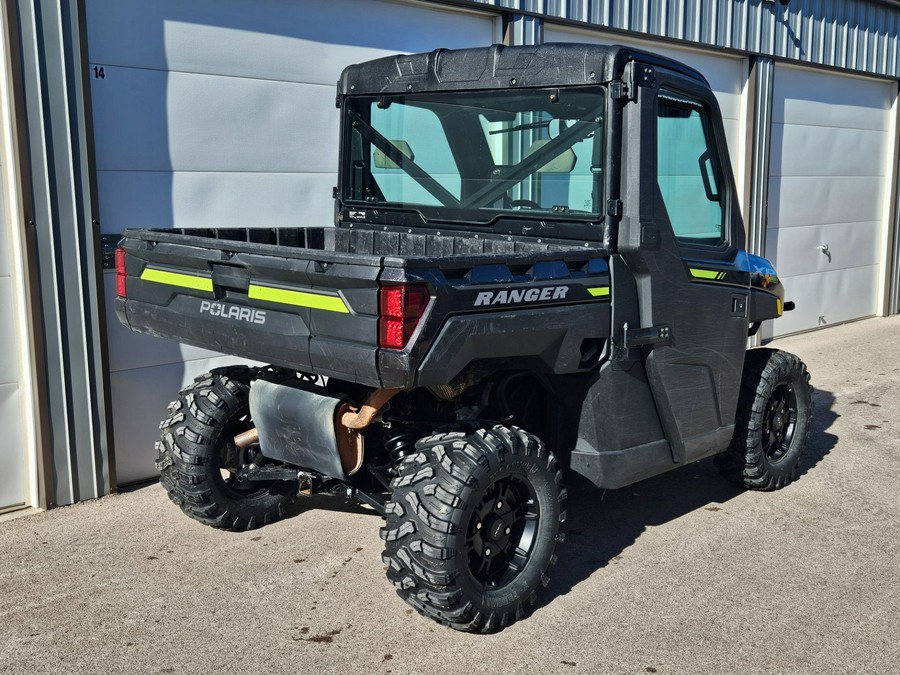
[769,176,884,227]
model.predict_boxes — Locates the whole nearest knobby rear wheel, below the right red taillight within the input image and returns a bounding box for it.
[381,425,566,633]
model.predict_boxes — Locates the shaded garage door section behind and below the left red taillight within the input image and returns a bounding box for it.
[103,274,221,372]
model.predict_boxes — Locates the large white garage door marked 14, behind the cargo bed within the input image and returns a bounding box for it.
[86,0,497,483]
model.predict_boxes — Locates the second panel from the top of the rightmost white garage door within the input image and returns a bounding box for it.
[769,124,887,176]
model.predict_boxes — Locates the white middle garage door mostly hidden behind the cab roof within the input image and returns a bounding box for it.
[544,25,748,197]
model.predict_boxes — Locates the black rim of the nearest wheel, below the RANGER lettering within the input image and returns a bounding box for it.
[466,476,540,588]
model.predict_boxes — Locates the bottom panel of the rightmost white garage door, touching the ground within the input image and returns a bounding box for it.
[763,266,880,339]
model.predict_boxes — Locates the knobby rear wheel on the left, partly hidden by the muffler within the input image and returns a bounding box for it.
[156,366,299,530]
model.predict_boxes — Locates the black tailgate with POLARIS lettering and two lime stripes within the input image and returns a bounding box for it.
[116,228,382,386]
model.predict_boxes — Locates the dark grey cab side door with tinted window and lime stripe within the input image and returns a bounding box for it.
[619,64,749,461]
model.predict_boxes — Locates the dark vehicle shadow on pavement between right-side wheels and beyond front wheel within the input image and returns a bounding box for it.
[534,391,838,610]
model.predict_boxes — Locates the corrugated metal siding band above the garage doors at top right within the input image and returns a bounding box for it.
[456,0,900,77]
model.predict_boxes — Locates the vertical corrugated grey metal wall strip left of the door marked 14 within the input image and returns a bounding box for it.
[15,0,115,507]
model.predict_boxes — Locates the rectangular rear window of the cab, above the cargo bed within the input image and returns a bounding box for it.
[343,87,604,222]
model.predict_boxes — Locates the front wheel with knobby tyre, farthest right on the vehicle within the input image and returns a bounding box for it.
[718,349,812,490]
